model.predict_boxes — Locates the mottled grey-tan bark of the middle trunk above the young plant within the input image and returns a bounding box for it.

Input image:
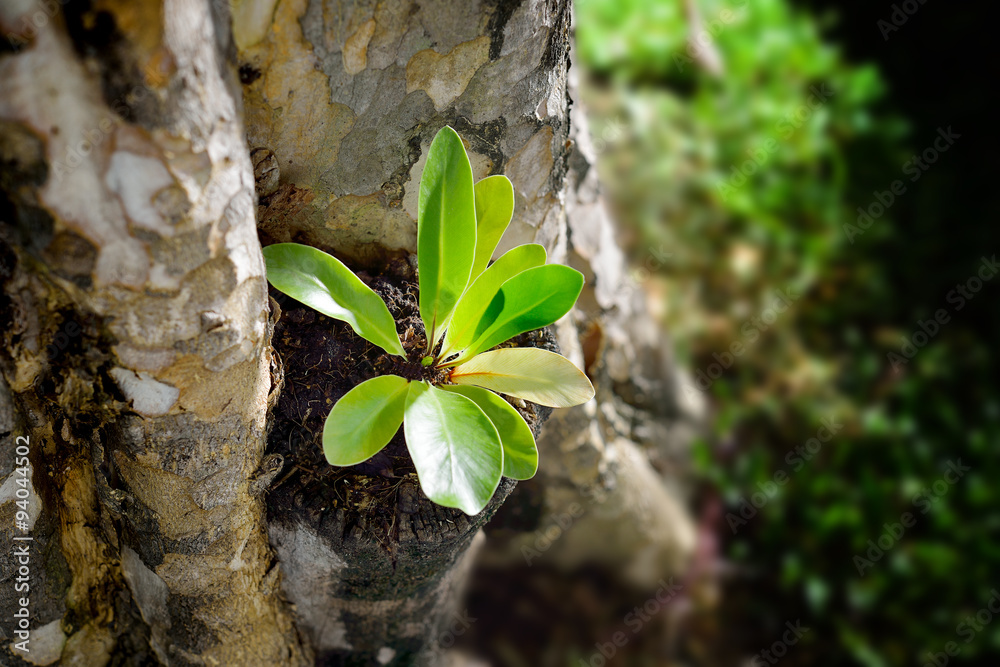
[234,0,569,262]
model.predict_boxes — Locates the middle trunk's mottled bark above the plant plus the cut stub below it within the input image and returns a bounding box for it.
[234,0,569,665]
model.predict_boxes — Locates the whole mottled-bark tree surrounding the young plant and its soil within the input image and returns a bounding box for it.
[0,0,694,665]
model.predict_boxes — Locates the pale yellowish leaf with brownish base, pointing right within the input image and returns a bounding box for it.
[451,347,594,408]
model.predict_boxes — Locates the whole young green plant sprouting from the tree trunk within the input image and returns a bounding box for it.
[264,127,594,514]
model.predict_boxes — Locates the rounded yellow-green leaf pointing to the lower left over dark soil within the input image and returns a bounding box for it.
[323,375,410,466]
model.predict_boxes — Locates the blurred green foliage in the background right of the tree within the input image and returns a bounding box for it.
[576,0,1000,667]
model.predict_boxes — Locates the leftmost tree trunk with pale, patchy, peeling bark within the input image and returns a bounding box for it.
[0,0,308,665]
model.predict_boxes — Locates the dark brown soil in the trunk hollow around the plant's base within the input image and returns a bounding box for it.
[268,253,556,556]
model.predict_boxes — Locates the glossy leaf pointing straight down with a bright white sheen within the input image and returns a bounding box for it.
[403,382,503,515]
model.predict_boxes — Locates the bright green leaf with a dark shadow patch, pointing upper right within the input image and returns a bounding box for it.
[445,264,583,366]
